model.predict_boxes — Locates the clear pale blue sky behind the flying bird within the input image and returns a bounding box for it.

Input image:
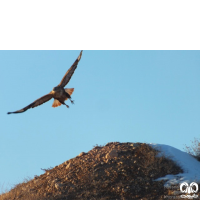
[0,50,200,192]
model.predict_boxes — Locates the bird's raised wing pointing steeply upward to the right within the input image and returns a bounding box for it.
[58,51,82,87]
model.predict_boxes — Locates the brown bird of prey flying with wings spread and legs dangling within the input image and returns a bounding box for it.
[7,51,82,114]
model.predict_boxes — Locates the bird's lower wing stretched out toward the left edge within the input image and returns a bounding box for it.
[7,94,53,114]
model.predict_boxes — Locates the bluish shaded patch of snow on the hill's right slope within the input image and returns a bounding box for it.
[149,143,200,187]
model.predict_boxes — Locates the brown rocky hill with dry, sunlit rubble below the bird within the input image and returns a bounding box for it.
[0,142,200,200]
